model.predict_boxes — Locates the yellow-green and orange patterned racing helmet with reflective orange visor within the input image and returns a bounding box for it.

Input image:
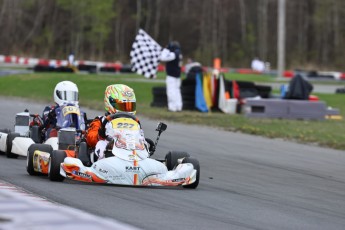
[104,84,136,114]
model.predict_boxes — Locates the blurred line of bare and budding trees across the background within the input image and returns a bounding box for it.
[0,0,345,70]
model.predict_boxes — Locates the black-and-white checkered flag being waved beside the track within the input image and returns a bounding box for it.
[130,29,162,78]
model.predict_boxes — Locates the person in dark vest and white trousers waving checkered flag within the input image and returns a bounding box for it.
[160,41,183,112]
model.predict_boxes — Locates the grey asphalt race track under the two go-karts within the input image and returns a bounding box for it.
[0,97,345,230]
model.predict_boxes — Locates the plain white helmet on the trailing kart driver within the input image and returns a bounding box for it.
[54,81,79,106]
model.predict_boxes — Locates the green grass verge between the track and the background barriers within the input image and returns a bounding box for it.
[0,73,345,149]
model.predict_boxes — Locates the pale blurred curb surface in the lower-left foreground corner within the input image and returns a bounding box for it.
[0,180,138,230]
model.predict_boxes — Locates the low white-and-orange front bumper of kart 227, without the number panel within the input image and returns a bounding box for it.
[60,156,197,186]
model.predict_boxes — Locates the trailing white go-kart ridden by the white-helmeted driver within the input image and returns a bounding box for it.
[0,104,86,158]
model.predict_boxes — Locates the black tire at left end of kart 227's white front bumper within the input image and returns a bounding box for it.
[48,150,67,182]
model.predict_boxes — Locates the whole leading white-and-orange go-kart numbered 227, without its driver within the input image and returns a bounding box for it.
[48,113,200,188]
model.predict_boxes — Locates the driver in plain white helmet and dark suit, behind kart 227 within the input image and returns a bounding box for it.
[42,81,79,140]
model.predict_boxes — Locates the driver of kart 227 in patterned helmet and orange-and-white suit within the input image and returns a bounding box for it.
[86,84,148,162]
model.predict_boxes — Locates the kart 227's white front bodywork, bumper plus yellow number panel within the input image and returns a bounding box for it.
[60,118,196,186]
